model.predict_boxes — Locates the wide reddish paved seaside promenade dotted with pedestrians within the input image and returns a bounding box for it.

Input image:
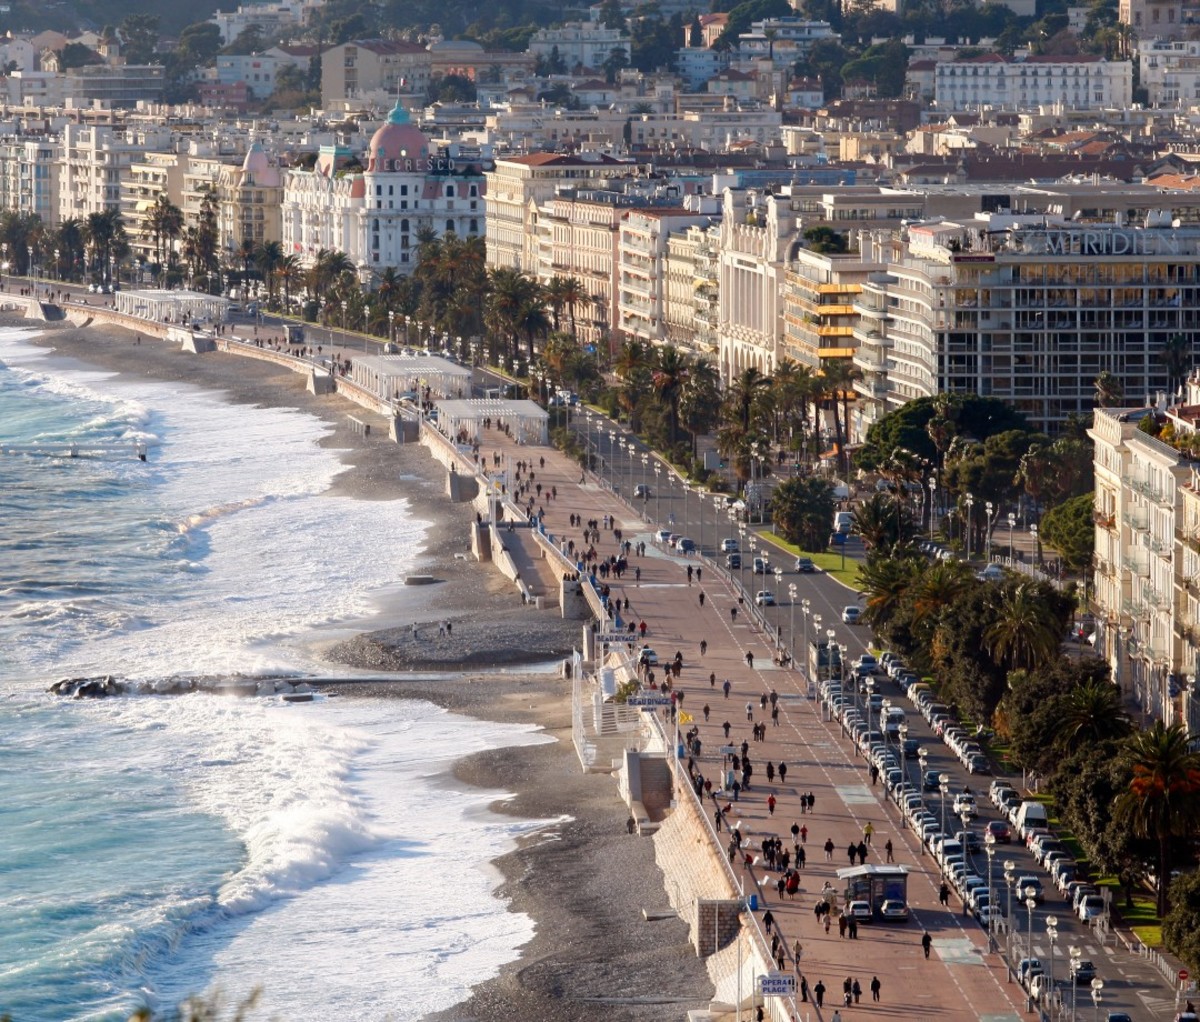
[468,417,1024,1022]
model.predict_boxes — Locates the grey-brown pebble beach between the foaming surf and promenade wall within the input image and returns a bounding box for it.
[5,318,712,1022]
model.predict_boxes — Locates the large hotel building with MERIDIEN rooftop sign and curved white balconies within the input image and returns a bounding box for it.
[854,214,1185,433]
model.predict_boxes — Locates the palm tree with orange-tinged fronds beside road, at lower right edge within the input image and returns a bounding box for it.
[1116,720,1200,918]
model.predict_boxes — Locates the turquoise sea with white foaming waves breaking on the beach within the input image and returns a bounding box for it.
[0,330,554,1022]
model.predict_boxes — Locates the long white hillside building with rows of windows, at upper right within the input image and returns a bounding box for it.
[934,53,1133,110]
